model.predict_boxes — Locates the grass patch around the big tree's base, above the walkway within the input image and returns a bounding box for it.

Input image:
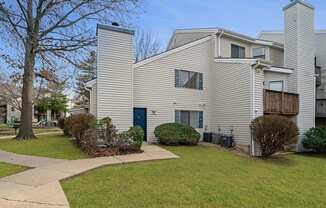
[0,134,87,160]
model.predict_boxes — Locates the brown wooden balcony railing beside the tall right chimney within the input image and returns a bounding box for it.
[264,89,299,116]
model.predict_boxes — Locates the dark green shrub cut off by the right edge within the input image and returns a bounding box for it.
[302,128,326,153]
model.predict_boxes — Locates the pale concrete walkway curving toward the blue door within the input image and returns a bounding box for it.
[0,144,178,208]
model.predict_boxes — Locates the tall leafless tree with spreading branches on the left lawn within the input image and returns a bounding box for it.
[0,0,140,140]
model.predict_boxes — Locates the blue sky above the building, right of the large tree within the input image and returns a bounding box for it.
[133,0,326,46]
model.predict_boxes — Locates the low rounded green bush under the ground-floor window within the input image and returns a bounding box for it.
[154,123,200,145]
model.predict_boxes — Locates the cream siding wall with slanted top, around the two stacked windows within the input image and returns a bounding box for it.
[133,39,213,142]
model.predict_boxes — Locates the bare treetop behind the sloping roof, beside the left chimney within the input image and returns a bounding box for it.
[135,31,161,62]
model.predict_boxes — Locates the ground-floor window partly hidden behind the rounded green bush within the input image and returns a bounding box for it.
[175,110,203,129]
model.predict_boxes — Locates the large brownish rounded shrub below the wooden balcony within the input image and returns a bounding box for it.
[250,115,299,157]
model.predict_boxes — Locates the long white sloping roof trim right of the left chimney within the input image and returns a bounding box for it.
[133,36,212,69]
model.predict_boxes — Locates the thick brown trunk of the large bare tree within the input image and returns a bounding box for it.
[16,39,36,140]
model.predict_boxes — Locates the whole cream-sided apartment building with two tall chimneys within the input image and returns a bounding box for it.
[87,0,318,154]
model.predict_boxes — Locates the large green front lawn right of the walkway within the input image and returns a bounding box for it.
[62,146,326,208]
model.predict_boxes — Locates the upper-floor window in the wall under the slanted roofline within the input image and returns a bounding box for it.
[175,70,203,90]
